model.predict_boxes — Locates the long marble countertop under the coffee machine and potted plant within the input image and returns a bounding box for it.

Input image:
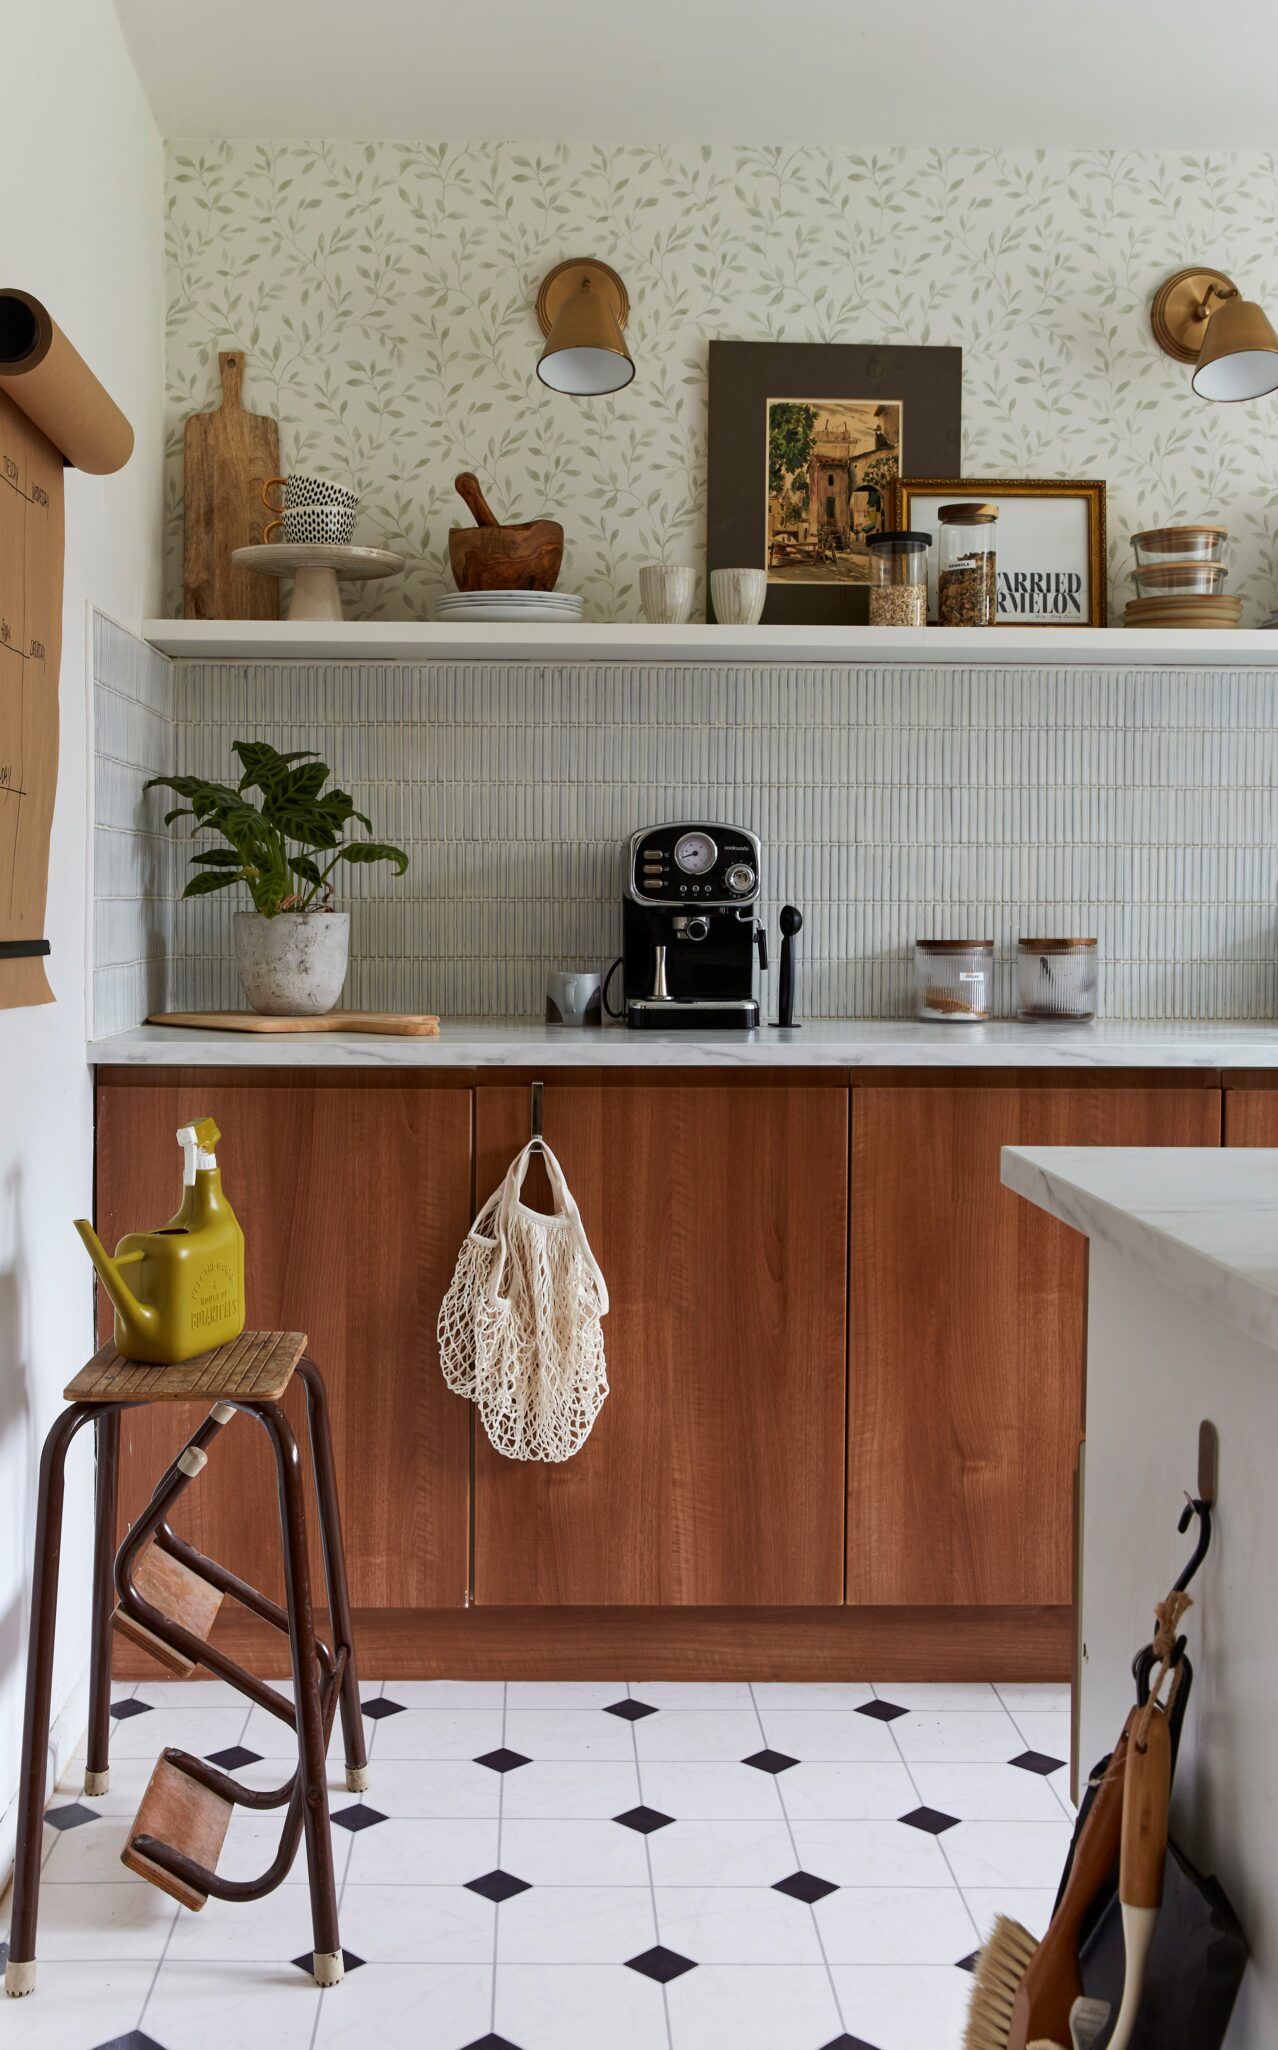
[88,1019,1278,1070]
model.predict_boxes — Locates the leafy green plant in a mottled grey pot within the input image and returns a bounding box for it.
[146,740,408,1017]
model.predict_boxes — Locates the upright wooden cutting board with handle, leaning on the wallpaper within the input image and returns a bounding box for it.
[183,349,279,619]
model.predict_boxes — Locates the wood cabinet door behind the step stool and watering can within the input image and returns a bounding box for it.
[94,1070,472,1607]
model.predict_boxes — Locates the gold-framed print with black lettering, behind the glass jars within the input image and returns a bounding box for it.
[890,478,1110,627]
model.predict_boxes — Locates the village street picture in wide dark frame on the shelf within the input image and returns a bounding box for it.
[706,342,962,625]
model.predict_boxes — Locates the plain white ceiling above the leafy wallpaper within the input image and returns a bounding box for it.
[117,0,1278,150]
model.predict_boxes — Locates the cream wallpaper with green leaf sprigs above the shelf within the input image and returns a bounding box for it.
[168,141,1278,623]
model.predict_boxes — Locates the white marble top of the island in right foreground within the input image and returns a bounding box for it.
[1003,1146,1278,1351]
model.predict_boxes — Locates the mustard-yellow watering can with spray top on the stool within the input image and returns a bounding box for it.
[76,1117,244,1367]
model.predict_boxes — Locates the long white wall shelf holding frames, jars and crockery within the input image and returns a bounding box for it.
[144,619,1278,668]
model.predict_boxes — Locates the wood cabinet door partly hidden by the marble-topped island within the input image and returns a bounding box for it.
[847,1084,1221,1605]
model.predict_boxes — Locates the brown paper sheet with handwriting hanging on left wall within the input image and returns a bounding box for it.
[0,392,62,1011]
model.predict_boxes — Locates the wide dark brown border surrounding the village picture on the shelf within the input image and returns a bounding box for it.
[706,342,962,625]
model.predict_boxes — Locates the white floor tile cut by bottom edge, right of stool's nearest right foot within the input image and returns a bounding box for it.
[307,1964,492,2050]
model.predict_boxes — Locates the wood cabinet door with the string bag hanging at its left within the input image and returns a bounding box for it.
[474,1078,847,1605]
